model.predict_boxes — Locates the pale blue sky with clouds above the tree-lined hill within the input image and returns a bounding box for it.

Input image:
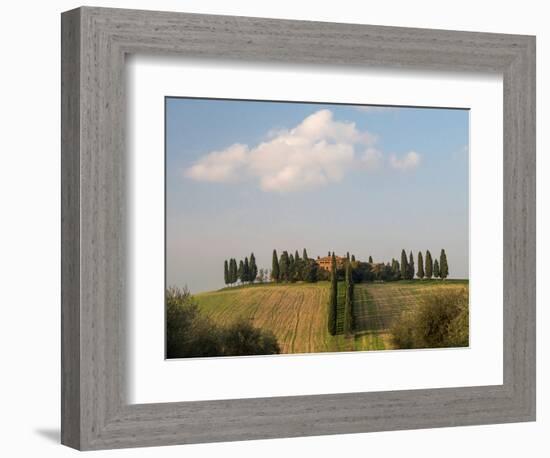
[166,98,469,292]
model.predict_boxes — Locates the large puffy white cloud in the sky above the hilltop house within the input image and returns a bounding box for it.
[184,110,416,193]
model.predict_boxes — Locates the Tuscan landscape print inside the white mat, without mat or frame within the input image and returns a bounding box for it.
[165,97,469,359]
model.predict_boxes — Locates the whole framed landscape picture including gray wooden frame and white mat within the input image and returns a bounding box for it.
[62,7,536,450]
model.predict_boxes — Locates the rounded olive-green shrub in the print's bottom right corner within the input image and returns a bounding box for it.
[390,288,469,348]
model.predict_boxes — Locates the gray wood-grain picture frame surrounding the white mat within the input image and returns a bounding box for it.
[61,7,535,450]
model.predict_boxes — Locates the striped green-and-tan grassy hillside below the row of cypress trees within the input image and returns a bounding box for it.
[194,280,468,353]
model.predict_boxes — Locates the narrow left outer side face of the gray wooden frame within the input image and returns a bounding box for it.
[61,11,81,448]
